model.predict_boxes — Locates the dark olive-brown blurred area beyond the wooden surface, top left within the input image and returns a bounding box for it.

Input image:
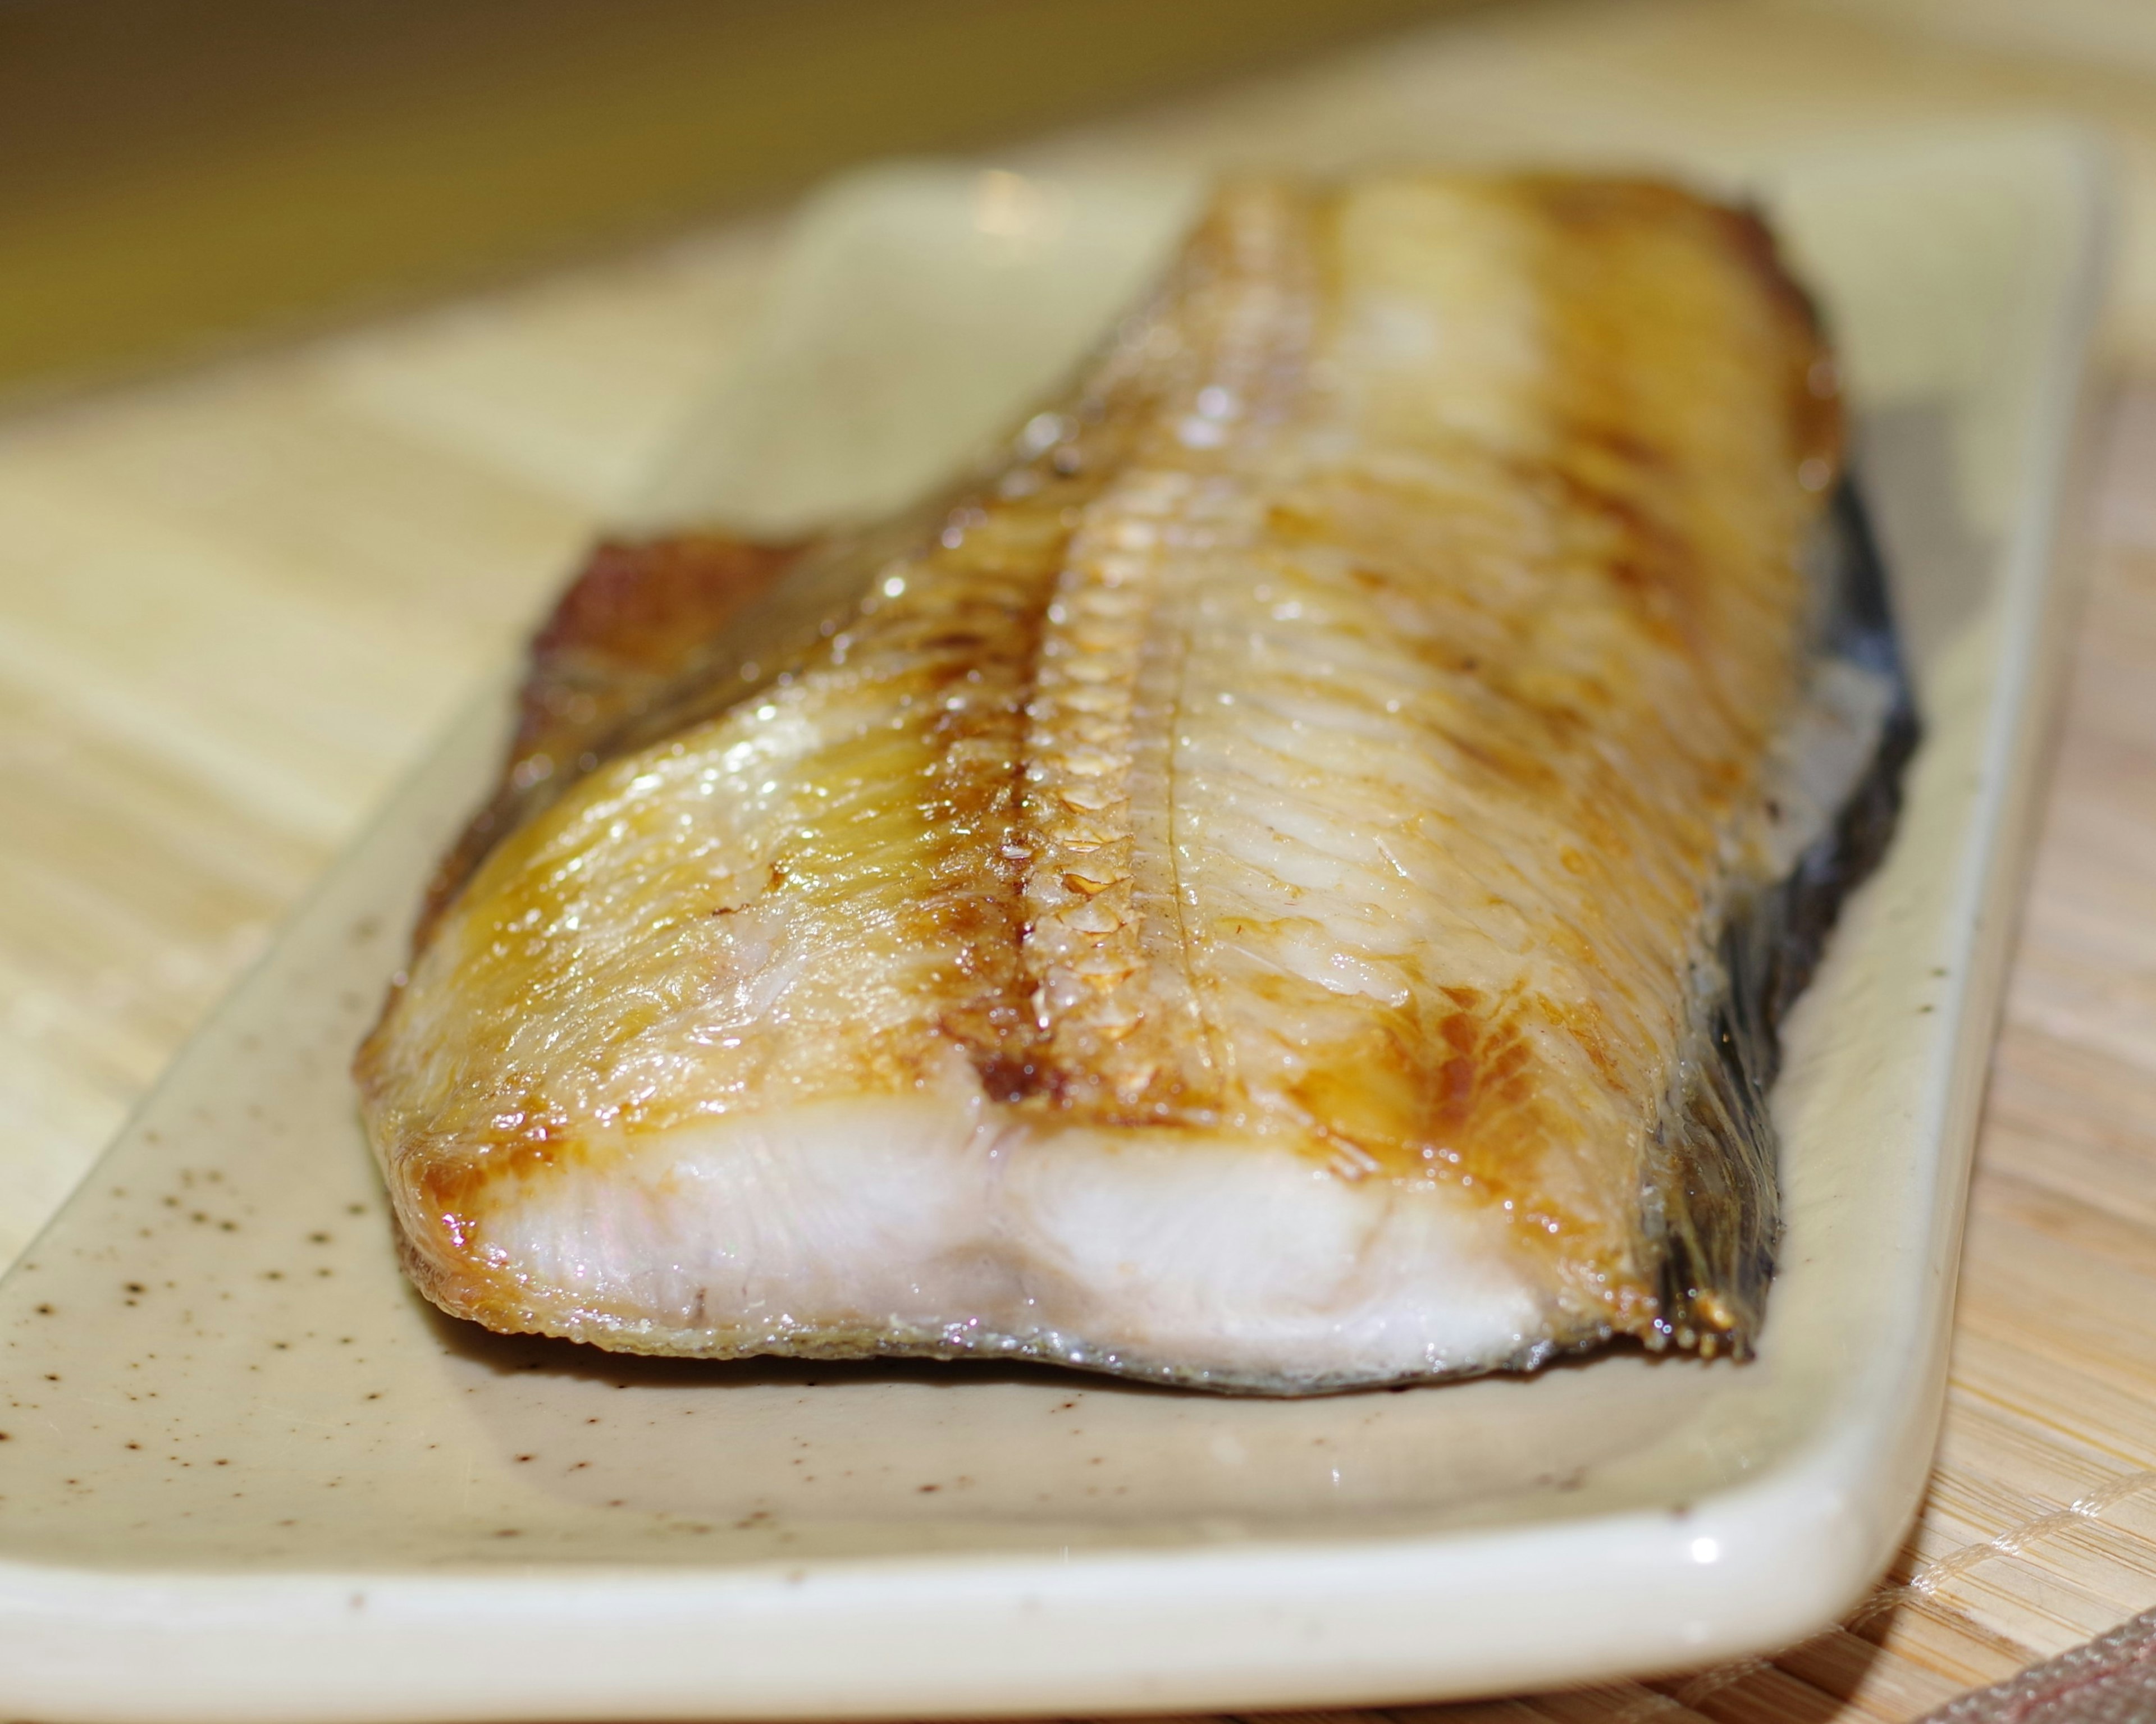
[0,0,1462,396]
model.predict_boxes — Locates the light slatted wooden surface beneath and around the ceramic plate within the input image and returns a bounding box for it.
[0,0,2156,1724]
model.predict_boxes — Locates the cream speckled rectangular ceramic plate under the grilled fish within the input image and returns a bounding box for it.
[0,134,2102,1720]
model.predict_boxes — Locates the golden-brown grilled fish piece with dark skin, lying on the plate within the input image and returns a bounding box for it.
[358,175,1915,1394]
